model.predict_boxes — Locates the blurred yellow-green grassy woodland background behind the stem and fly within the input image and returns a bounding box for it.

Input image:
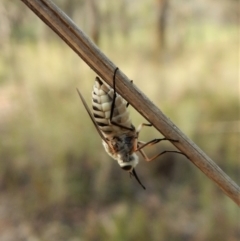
[0,0,240,241]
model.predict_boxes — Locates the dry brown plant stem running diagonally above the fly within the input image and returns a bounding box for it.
[21,0,240,206]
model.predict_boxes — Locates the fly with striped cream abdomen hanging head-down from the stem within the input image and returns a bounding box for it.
[77,68,183,189]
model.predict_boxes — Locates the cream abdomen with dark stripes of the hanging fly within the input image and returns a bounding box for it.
[92,77,134,136]
